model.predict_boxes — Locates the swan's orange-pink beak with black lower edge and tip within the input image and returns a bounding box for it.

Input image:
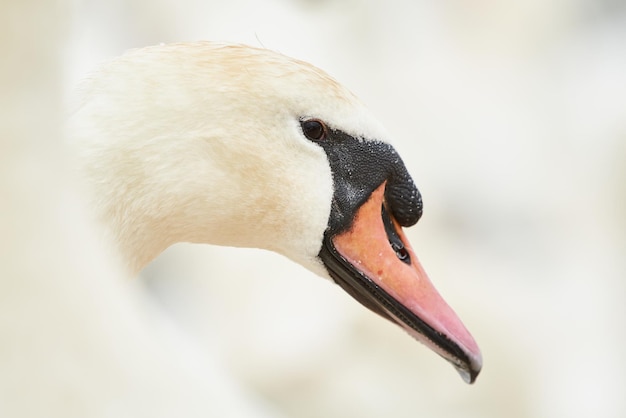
[320,183,482,383]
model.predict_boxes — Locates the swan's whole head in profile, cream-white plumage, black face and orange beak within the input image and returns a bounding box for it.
[68,42,482,383]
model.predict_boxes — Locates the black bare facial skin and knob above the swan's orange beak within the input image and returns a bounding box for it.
[302,125,422,235]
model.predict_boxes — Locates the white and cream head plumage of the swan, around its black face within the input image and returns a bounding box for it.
[70,42,385,275]
